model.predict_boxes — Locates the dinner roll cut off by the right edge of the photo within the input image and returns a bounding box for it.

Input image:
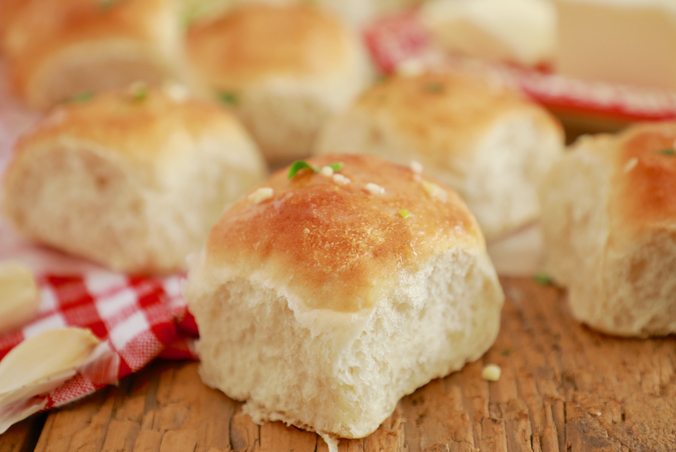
[542,122,676,336]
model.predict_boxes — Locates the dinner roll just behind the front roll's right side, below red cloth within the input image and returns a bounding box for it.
[316,74,563,241]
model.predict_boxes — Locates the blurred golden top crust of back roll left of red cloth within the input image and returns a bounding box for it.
[188,4,352,85]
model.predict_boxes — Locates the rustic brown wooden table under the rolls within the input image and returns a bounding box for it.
[0,278,676,452]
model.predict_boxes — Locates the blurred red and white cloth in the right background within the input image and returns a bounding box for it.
[364,11,676,121]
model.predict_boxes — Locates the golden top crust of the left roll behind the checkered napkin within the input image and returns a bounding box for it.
[7,87,262,188]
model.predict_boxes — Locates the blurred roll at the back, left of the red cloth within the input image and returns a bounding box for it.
[188,5,367,163]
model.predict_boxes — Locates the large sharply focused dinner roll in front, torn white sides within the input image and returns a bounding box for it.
[185,155,503,440]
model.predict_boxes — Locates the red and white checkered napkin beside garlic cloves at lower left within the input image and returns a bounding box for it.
[0,271,197,430]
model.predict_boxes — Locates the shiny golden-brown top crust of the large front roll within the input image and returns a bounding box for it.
[206,155,485,312]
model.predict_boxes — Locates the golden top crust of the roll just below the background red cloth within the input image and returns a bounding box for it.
[332,73,563,164]
